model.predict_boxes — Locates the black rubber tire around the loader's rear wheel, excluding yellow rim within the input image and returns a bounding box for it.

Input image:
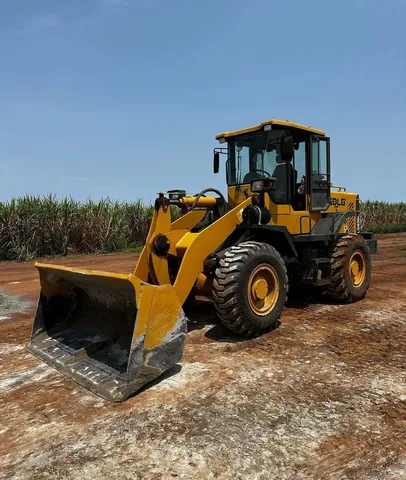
[327,234,371,303]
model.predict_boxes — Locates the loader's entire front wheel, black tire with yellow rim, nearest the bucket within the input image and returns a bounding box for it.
[213,241,288,337]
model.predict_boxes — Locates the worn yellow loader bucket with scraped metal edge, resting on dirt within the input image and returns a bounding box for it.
[27,263,186,402]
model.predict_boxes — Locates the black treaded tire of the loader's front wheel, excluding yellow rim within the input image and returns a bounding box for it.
[213,241,288,337]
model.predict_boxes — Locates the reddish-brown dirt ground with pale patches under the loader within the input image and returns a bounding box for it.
[0,234,406,480]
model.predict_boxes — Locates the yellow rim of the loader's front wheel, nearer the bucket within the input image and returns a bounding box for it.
[248,263,279,316]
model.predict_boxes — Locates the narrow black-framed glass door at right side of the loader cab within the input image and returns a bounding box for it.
[308,136,331,212]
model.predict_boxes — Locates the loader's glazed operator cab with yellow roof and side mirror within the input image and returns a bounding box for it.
[214,120,330,211]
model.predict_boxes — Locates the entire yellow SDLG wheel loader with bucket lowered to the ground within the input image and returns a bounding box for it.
[27,120,377,401]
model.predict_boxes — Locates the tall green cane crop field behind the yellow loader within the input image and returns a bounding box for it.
[0,195,406,260]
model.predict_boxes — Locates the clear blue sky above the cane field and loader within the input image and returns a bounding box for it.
[0,0,406,202]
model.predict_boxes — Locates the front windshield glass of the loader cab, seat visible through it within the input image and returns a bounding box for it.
[227,132,293,203]
